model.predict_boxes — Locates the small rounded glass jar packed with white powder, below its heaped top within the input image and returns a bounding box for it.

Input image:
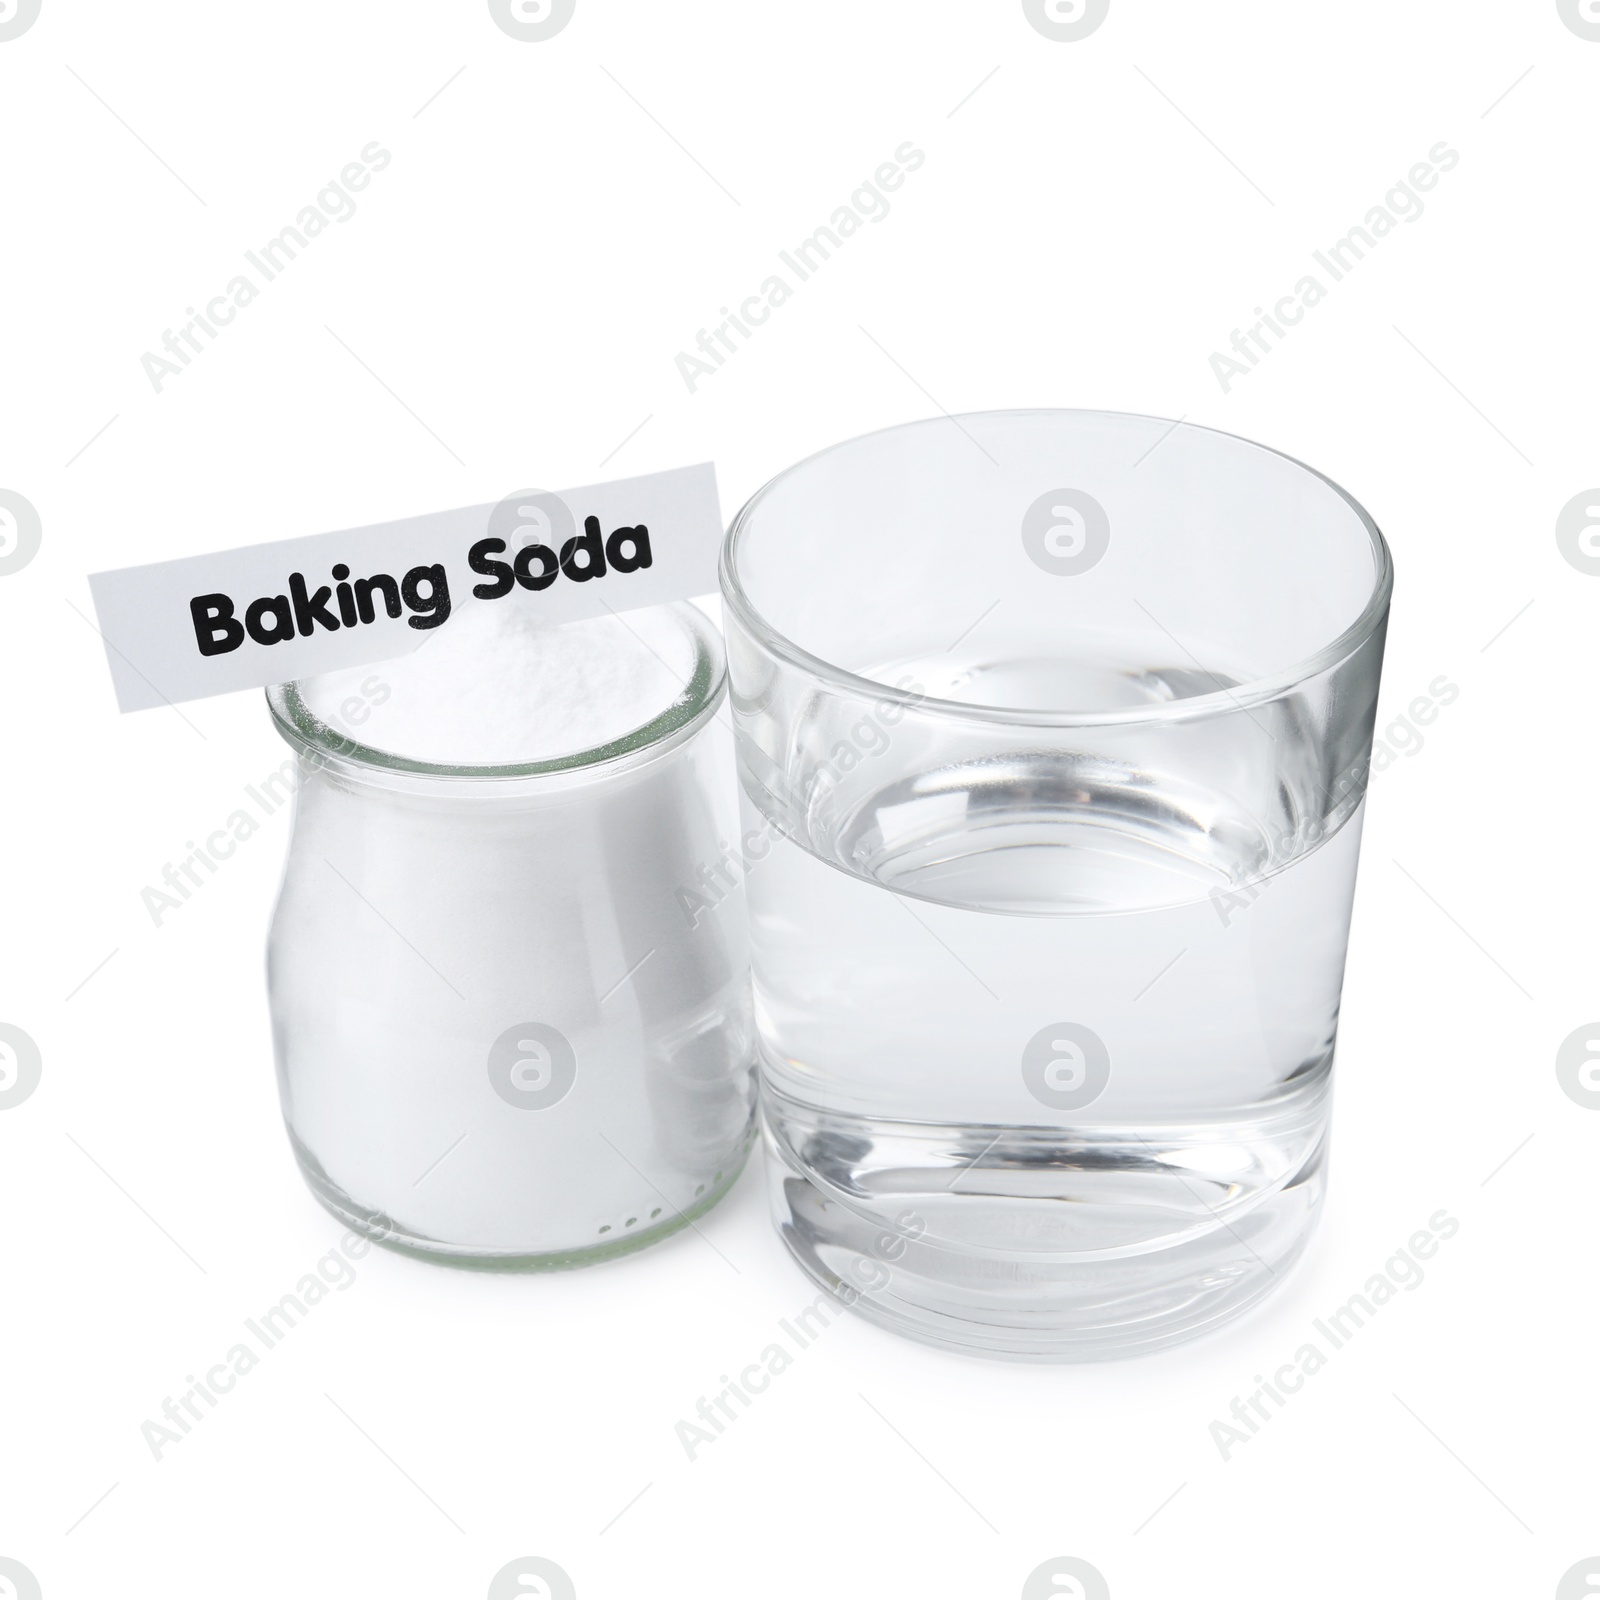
[267,605,754,1269]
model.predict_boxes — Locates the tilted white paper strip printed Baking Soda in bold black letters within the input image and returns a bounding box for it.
[90,464,722,710]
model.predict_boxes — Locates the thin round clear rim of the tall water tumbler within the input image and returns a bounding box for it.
[717,406,1394,728]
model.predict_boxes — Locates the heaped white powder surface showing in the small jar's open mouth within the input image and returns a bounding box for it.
[299,594,694,766]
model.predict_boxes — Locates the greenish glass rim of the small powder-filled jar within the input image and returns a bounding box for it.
[266,600,728,789]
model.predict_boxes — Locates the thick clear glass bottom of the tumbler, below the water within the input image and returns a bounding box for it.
[765,1096,1325,1362]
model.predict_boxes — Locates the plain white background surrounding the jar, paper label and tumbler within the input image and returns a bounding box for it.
[0,0,1600,1600]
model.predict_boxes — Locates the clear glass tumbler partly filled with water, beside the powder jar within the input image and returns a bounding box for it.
[722,411,1392,1360]
